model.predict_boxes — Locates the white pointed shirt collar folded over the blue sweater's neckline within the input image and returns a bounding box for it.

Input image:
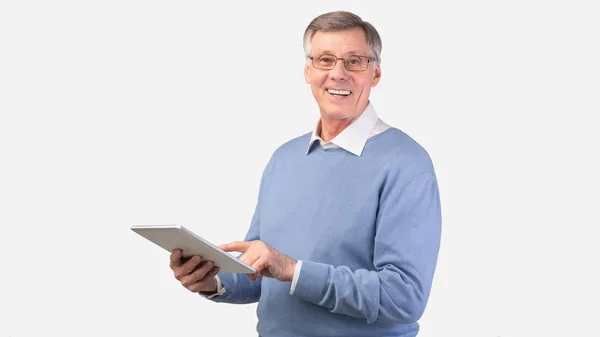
[306,102,378,156]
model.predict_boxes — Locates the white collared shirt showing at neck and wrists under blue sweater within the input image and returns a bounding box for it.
[201,102,390,299]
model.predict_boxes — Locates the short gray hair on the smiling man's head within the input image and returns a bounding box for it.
[304,11,381,61]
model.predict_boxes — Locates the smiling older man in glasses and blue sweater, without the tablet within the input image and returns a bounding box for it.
[171,12,441,337]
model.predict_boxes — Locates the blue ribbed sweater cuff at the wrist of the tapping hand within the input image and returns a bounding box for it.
[293,261,330,304]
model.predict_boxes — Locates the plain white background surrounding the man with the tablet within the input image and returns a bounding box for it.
[0,0,600,337]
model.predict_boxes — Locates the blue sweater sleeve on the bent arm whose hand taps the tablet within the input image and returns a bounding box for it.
[293,171,441,324]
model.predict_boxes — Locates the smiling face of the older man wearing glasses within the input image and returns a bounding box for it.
[304,27,381,120]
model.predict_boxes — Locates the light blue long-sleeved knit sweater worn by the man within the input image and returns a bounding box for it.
[212,128,441,337]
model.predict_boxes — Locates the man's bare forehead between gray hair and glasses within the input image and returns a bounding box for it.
[310,27,369,54]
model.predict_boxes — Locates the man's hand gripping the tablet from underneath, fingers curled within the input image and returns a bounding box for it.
[170,249,219,293]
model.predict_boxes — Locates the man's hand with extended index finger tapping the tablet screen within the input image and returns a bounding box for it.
[219,240,296,282]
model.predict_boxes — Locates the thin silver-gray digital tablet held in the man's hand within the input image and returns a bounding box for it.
[131,225,256,274]
